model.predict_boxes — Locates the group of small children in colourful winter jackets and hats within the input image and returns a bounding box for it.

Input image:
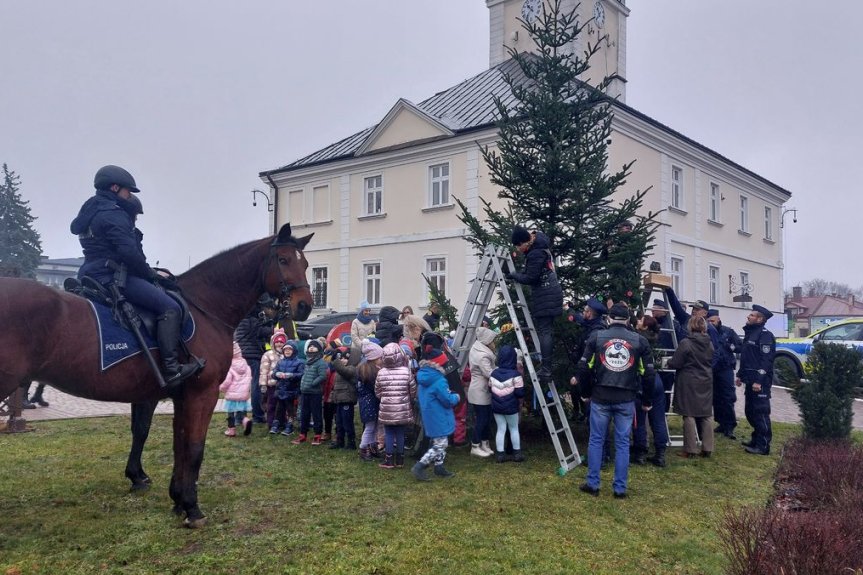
[220,320,524,481]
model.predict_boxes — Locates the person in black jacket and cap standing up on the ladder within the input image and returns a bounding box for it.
[505,225,563,383]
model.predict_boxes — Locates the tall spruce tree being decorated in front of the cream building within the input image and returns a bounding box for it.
[458,0,658,304]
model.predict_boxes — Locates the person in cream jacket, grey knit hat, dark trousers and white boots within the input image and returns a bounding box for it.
[467,327,497,457]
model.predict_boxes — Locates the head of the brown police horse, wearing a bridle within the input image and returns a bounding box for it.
[263,224,315,321]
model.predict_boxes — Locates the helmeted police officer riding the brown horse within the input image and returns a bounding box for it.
[70,165,200,388]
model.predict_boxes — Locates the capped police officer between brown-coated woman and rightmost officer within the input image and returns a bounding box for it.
[707,309,743,439]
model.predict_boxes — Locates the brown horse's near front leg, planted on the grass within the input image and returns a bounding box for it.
[172,385,219,528]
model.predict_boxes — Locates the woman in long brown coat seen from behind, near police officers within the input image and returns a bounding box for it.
[668,317,713,457]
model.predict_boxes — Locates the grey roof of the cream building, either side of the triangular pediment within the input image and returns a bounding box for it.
[261,60,524,176]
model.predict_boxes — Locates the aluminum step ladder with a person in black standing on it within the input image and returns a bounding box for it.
[452,245,581,475]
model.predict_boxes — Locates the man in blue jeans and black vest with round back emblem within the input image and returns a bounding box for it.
[577,303,655,499]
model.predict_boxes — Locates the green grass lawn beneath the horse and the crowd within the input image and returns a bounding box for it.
[0,414,828,575]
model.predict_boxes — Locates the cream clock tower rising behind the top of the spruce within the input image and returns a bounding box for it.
[485,0,629,102]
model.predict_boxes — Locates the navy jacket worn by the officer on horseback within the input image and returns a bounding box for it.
[70,190,153,283]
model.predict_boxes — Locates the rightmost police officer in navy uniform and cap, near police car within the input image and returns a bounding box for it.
[737,305,776,455]
